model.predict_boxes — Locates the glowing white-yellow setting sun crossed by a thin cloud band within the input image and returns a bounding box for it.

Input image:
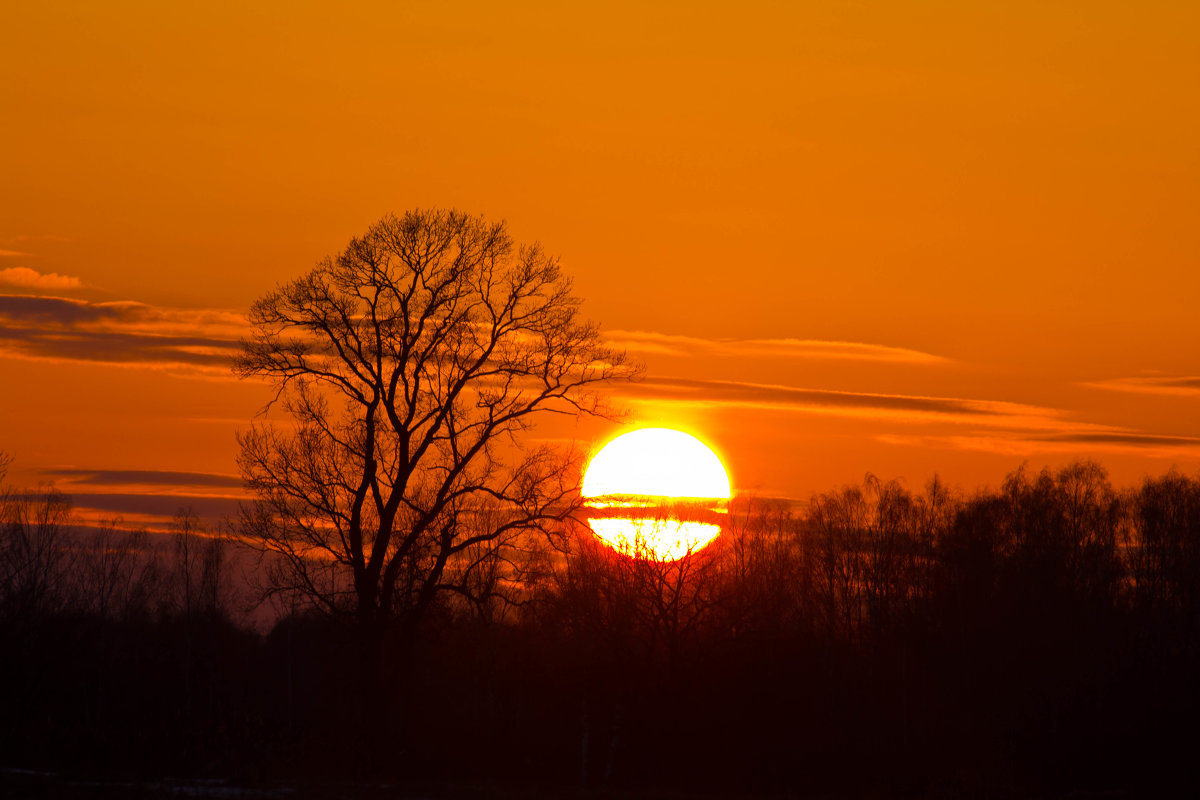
[582,428,730,561]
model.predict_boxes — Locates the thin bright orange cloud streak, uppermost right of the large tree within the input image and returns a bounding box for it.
[606,330,948,363]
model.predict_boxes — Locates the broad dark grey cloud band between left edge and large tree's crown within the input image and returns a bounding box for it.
[0,295,245,375]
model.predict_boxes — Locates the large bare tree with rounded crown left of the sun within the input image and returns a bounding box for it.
[234,210,636,695]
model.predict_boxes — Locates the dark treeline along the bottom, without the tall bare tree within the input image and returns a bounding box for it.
[7,463,1200,796]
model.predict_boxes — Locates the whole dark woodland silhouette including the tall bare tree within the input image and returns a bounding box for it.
[0,209,1200,796]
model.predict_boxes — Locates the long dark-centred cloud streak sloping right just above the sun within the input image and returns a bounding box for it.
[614,378,1066,429]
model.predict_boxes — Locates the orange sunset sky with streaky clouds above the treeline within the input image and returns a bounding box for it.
[0,0,1200,522]
